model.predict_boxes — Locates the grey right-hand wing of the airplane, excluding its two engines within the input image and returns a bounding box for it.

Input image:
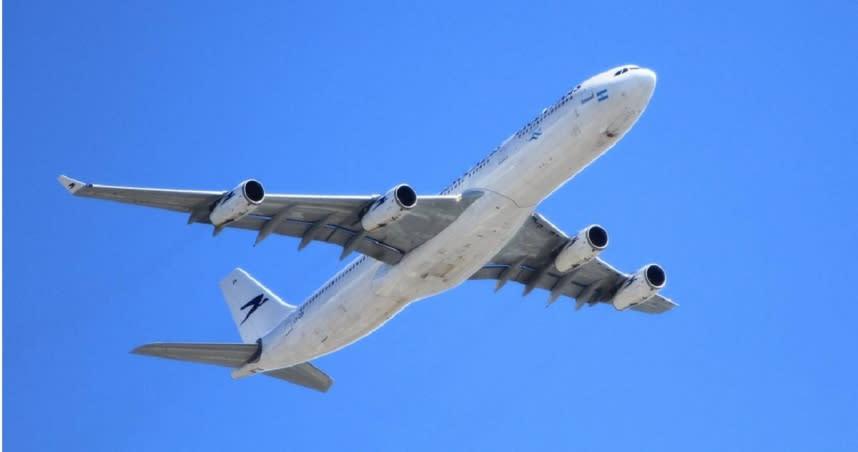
[471,214,677,314]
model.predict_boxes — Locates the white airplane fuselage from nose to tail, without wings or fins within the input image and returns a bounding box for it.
[244,67,655,376]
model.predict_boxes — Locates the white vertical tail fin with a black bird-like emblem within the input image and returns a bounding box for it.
[220,268,295,343]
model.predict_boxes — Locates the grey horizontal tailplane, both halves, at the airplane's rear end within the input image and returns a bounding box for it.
[131,343,334,392]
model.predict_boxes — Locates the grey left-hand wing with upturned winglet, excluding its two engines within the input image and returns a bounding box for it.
[59,176,482,264]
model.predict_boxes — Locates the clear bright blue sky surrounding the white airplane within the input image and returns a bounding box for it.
[3,1,858,451]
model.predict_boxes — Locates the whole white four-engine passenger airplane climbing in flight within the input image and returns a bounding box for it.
[59,66,676,392]
